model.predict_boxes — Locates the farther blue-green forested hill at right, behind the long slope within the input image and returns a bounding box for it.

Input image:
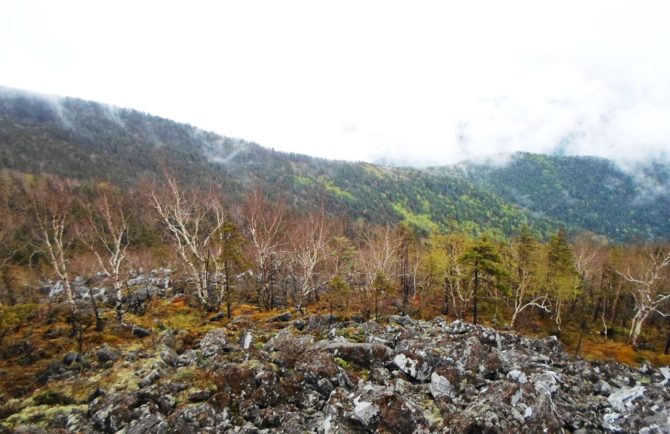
[460,153,670,240]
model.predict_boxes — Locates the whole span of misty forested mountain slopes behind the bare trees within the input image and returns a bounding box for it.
[0,88,670,240]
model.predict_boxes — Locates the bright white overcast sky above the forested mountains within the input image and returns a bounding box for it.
[0,0,670,166]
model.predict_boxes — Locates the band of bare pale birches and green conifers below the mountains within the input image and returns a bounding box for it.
[0,171,670,353]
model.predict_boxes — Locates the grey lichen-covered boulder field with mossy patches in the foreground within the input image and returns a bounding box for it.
[0,314,670,434]
